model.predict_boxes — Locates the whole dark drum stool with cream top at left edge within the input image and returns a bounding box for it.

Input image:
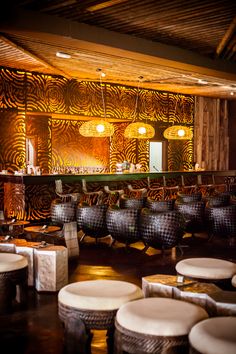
[0,253,28,314]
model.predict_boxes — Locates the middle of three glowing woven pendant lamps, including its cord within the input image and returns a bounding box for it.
[124,76,155,139]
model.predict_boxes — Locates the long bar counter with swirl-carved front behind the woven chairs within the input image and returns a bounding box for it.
[0,170,236,221]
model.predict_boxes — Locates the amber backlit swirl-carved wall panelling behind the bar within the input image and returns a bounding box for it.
[0,69,194,172]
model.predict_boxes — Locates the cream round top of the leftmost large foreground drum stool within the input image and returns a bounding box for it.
[58,280,143,311]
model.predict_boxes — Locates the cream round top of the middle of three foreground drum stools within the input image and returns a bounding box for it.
[116,297,208,336]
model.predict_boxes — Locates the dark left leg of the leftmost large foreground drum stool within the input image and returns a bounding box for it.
[65,317,89,354]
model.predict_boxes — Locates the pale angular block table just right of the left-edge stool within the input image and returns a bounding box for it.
[34,245,68,291]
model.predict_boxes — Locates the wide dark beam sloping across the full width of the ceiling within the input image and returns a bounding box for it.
[0,9,236,80]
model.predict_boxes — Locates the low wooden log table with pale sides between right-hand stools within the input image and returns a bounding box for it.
[142,274,236,316]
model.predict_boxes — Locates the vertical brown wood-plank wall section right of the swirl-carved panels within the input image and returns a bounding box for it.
[194,97,229,170]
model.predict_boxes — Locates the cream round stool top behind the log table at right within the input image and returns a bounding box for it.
[175,258,236,280]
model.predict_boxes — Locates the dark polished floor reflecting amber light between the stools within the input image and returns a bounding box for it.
[0,234,236,354]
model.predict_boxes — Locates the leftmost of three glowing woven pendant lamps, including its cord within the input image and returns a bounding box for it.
[79,69,114,138]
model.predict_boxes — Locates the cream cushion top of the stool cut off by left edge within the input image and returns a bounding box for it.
[0,253,28,272]
